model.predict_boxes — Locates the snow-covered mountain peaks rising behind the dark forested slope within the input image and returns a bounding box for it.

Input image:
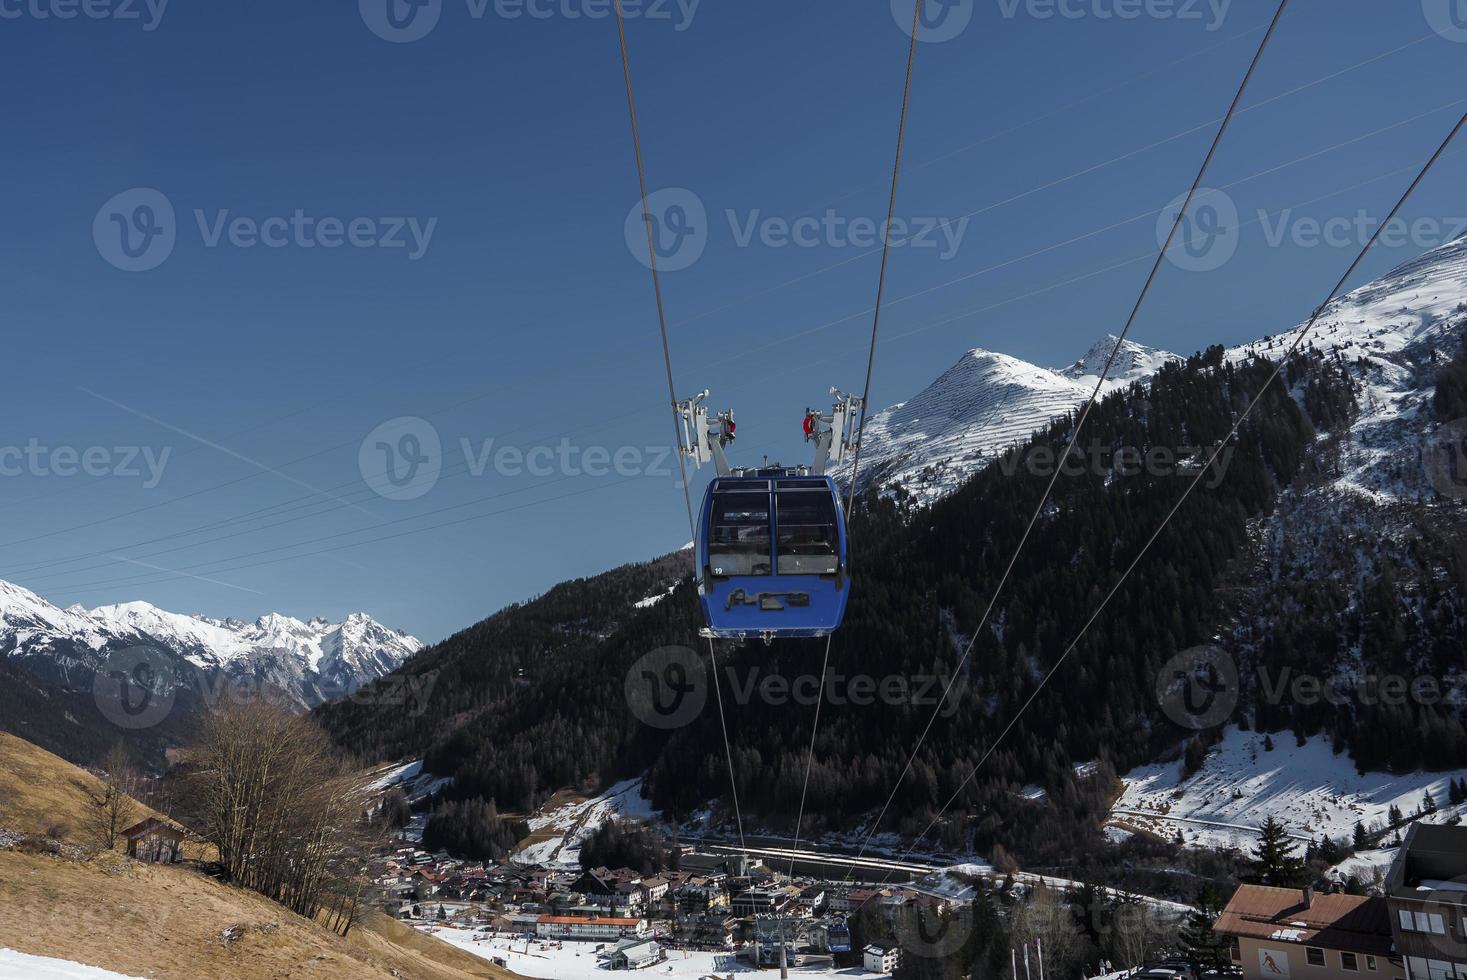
[836,230,1467,503]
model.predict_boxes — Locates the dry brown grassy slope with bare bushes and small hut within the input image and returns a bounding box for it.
[0,735,513,980]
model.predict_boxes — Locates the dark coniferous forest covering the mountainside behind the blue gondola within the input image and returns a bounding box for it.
[318,338,1467,864]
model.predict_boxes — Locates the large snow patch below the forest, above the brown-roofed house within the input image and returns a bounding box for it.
[1111,726,1467,849]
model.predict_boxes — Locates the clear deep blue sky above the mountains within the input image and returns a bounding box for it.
[0,0,1467,640]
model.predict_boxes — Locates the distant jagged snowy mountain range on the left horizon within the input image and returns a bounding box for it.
[0,581,422,707]
